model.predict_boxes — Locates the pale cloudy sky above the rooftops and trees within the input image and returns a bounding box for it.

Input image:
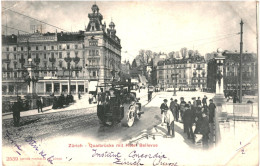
[2,1,256,61]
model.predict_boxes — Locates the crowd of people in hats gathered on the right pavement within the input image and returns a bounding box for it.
[160,96,216,148]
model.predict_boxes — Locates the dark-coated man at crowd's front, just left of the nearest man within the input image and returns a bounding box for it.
[183,104,194,143]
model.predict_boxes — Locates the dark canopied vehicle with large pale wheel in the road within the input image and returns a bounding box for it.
[97,82,144,127]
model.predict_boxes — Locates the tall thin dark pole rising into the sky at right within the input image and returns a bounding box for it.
[239,19,244,103]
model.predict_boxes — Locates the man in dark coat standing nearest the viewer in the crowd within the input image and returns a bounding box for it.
[200,112,210,149]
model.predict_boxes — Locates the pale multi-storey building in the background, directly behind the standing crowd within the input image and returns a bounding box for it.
[157,57,207,89]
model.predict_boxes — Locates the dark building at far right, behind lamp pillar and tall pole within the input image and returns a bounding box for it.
[207,52,258,94]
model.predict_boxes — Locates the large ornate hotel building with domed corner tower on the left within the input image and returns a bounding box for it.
[2,4,121,95]
